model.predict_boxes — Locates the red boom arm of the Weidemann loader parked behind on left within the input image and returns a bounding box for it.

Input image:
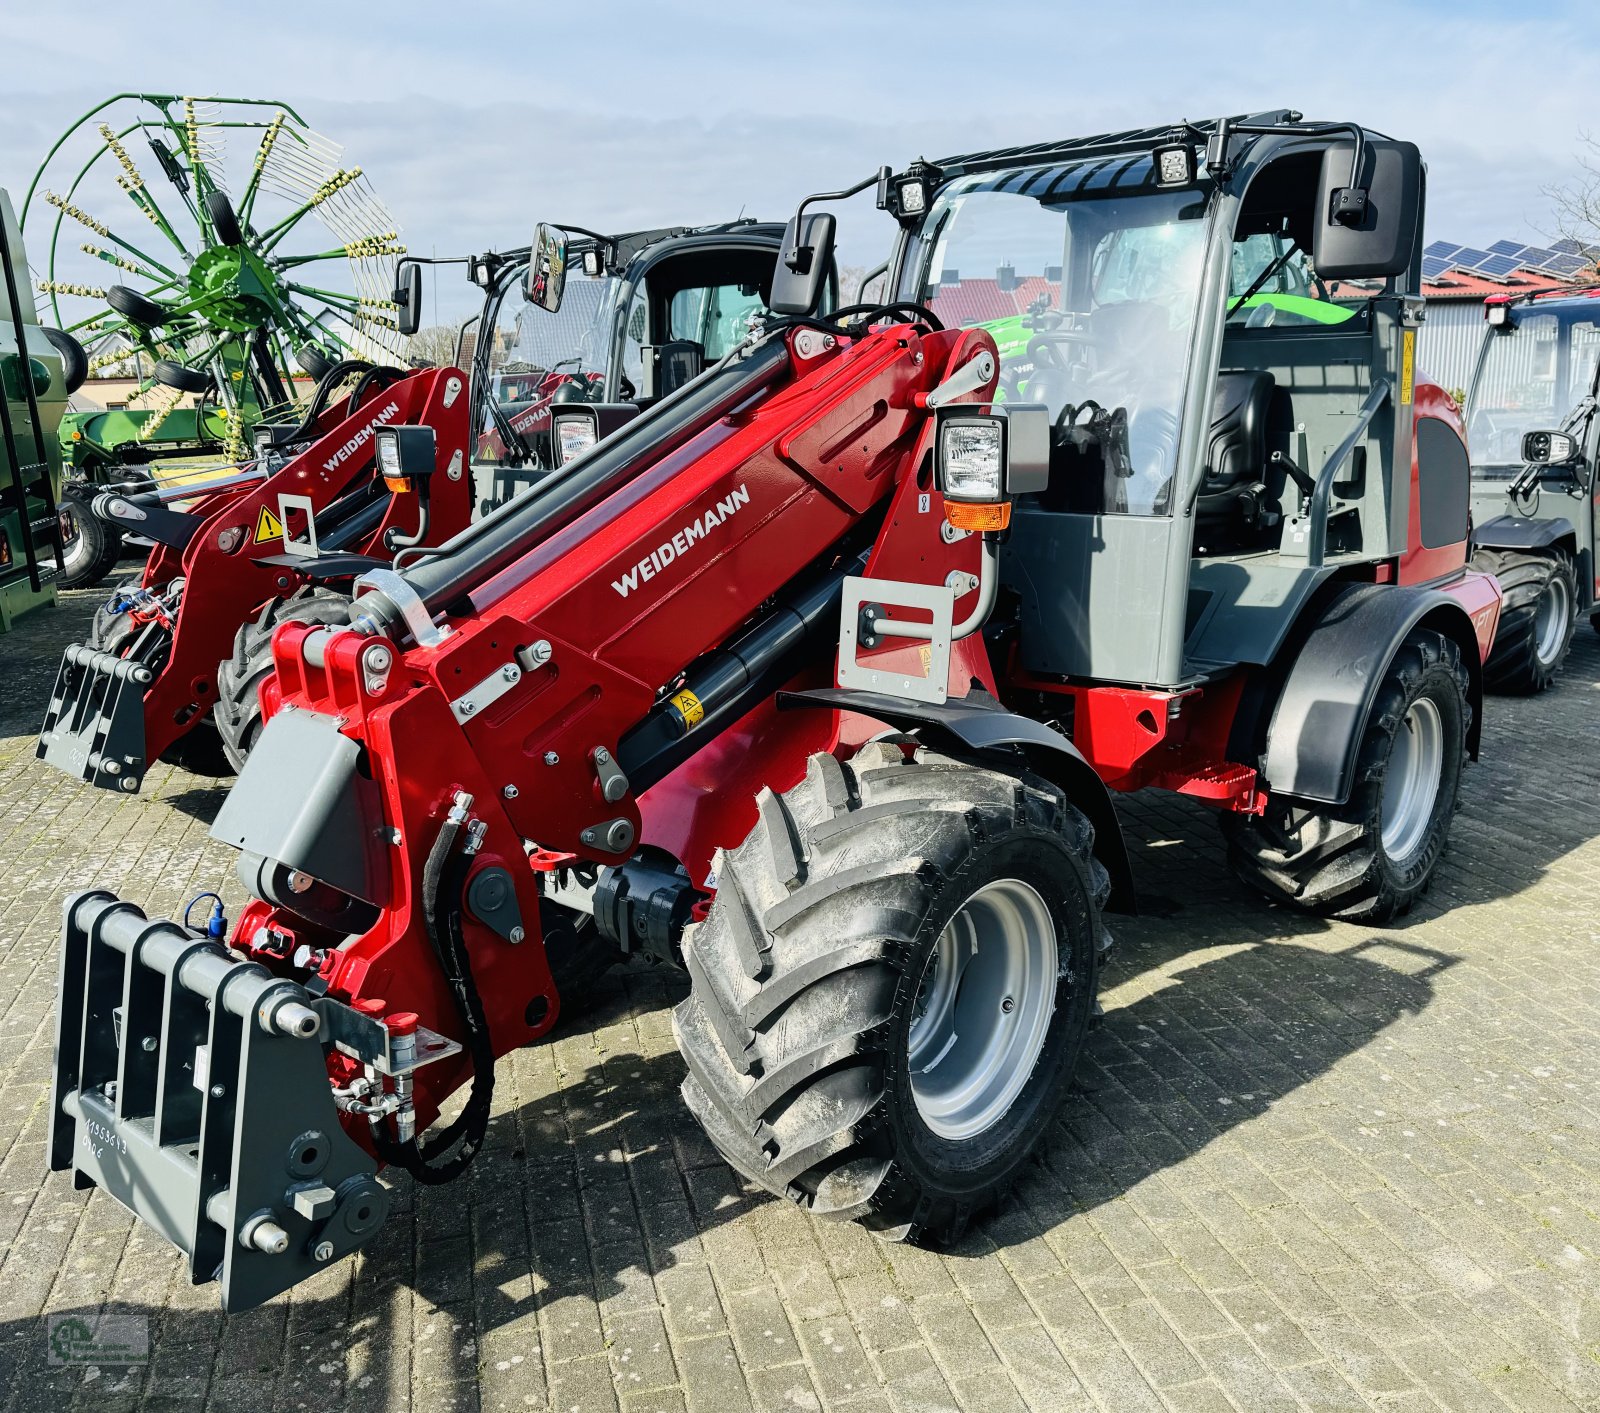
[114,368,472,762]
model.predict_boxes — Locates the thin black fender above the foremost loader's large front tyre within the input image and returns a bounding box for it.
[778,686,1136,912]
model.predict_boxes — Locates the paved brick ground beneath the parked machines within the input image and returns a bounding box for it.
[0,576,1600,1413]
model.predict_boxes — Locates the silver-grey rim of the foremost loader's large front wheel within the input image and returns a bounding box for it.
[907,879,1059,1139]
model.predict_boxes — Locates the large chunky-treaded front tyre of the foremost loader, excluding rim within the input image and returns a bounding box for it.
[674,743,1110,1242]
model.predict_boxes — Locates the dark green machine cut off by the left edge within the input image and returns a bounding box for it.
[0,190,74,632]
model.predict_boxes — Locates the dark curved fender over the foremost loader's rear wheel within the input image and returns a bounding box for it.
[1262,584,1483,805]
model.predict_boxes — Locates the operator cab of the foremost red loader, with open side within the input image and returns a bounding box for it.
[896,114,1467,688]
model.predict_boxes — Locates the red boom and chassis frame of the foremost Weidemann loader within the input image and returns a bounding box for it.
[232,326,1493,1147]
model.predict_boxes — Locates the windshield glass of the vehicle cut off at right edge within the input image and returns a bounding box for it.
[1467,309,1600,480]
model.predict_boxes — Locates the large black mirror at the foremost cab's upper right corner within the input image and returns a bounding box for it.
[1310,136,1422,280]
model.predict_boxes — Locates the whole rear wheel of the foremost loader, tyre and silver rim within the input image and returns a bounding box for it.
[1222,629,1472,922]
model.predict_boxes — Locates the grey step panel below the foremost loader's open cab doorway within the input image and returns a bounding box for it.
[1184,554,1334,672]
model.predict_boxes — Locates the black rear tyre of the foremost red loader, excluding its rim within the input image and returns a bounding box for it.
[1221,629,1472,923]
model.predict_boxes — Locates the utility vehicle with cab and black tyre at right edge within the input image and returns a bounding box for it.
[1466,290,1600,691]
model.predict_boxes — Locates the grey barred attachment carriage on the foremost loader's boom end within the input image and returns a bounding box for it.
[50,891,389,1311]
